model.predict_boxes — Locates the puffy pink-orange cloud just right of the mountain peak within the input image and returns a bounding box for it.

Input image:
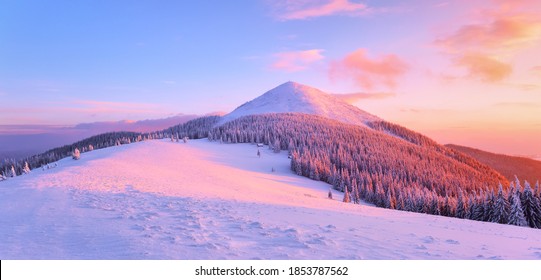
[329,49,408,90]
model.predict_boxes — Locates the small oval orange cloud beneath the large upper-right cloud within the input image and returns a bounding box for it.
[456,53,512,82]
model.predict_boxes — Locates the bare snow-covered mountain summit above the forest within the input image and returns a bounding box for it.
[218,82,381,126]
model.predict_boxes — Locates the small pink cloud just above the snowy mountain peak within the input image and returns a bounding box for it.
[271,49,325,72]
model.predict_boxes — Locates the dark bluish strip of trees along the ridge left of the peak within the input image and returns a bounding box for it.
[0,116,220,181]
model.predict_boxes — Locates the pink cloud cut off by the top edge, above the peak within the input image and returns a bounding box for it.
[272,0,368,20]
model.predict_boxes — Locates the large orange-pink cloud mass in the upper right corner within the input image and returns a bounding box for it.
[435,0,541,83]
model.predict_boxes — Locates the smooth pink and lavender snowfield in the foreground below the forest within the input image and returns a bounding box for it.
[0,139,541,259]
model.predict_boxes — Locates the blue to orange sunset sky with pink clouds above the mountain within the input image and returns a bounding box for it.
[0,0,541,155]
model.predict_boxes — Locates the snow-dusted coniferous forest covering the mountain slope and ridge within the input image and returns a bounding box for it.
[0,113,541,228]
